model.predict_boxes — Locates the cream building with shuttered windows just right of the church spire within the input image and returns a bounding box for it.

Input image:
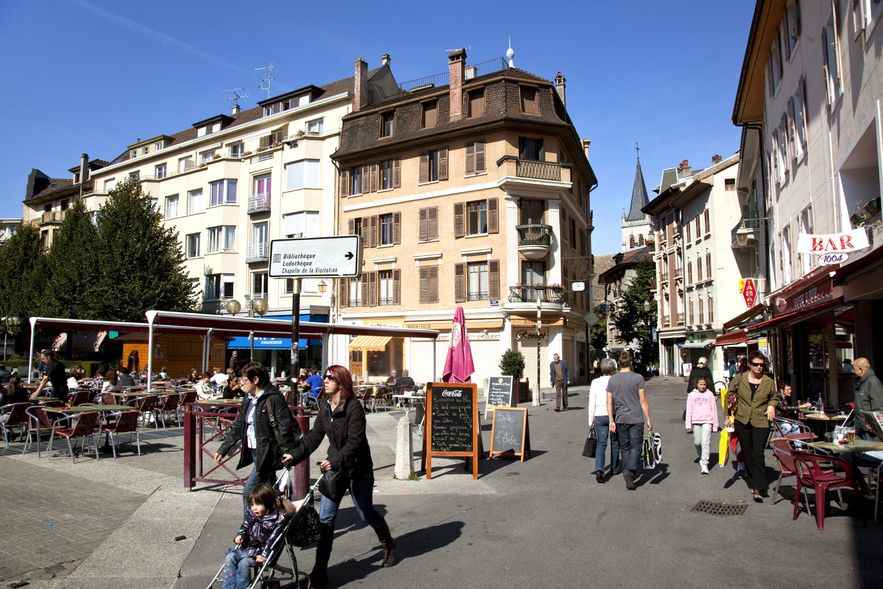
[644,154,746,378]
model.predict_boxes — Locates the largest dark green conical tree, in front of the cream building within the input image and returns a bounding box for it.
[90,180,196,322]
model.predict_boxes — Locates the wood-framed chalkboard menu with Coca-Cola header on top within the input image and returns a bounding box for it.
[425,382,481,479]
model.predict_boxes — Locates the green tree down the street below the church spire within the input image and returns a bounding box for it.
[611,261,659,366]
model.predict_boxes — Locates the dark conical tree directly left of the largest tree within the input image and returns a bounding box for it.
[40,200,100,319]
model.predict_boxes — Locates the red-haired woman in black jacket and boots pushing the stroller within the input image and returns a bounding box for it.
[292,365,396,588]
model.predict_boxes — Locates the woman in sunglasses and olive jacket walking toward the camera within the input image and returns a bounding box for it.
[730,352,779,503]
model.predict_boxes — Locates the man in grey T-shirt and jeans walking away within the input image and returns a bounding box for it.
[607,351,653,491]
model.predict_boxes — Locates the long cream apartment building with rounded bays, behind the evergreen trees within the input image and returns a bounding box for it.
[23,60,400,370]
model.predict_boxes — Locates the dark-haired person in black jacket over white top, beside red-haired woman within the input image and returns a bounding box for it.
[214,362,300,519]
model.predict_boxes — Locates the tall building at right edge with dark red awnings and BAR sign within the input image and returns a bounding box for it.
[729,0,883,405]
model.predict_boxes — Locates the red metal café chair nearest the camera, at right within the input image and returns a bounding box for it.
[792,452,856,530]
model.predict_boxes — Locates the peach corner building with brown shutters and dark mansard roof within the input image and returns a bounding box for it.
[334,49,597,387]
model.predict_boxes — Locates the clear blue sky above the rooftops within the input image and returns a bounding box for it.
[0,0,753,254]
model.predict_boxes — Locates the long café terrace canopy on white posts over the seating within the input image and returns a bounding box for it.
[28,310,438,388]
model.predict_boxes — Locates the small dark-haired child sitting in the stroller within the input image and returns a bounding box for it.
[221,485,286,589]
